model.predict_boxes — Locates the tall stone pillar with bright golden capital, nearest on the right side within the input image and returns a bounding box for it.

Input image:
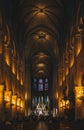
[74,29,84,120]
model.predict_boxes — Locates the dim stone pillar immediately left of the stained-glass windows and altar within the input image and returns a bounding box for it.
[24,64,31,116]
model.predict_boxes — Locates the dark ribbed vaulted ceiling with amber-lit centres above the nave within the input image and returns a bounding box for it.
[4,0,75,77]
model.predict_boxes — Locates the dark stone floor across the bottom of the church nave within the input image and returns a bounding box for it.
[0,120,84,130]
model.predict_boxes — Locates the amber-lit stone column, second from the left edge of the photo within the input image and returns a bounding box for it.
[4,44,12,120]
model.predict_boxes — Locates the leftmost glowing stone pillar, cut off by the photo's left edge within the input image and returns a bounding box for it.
[0,29,5,122]
